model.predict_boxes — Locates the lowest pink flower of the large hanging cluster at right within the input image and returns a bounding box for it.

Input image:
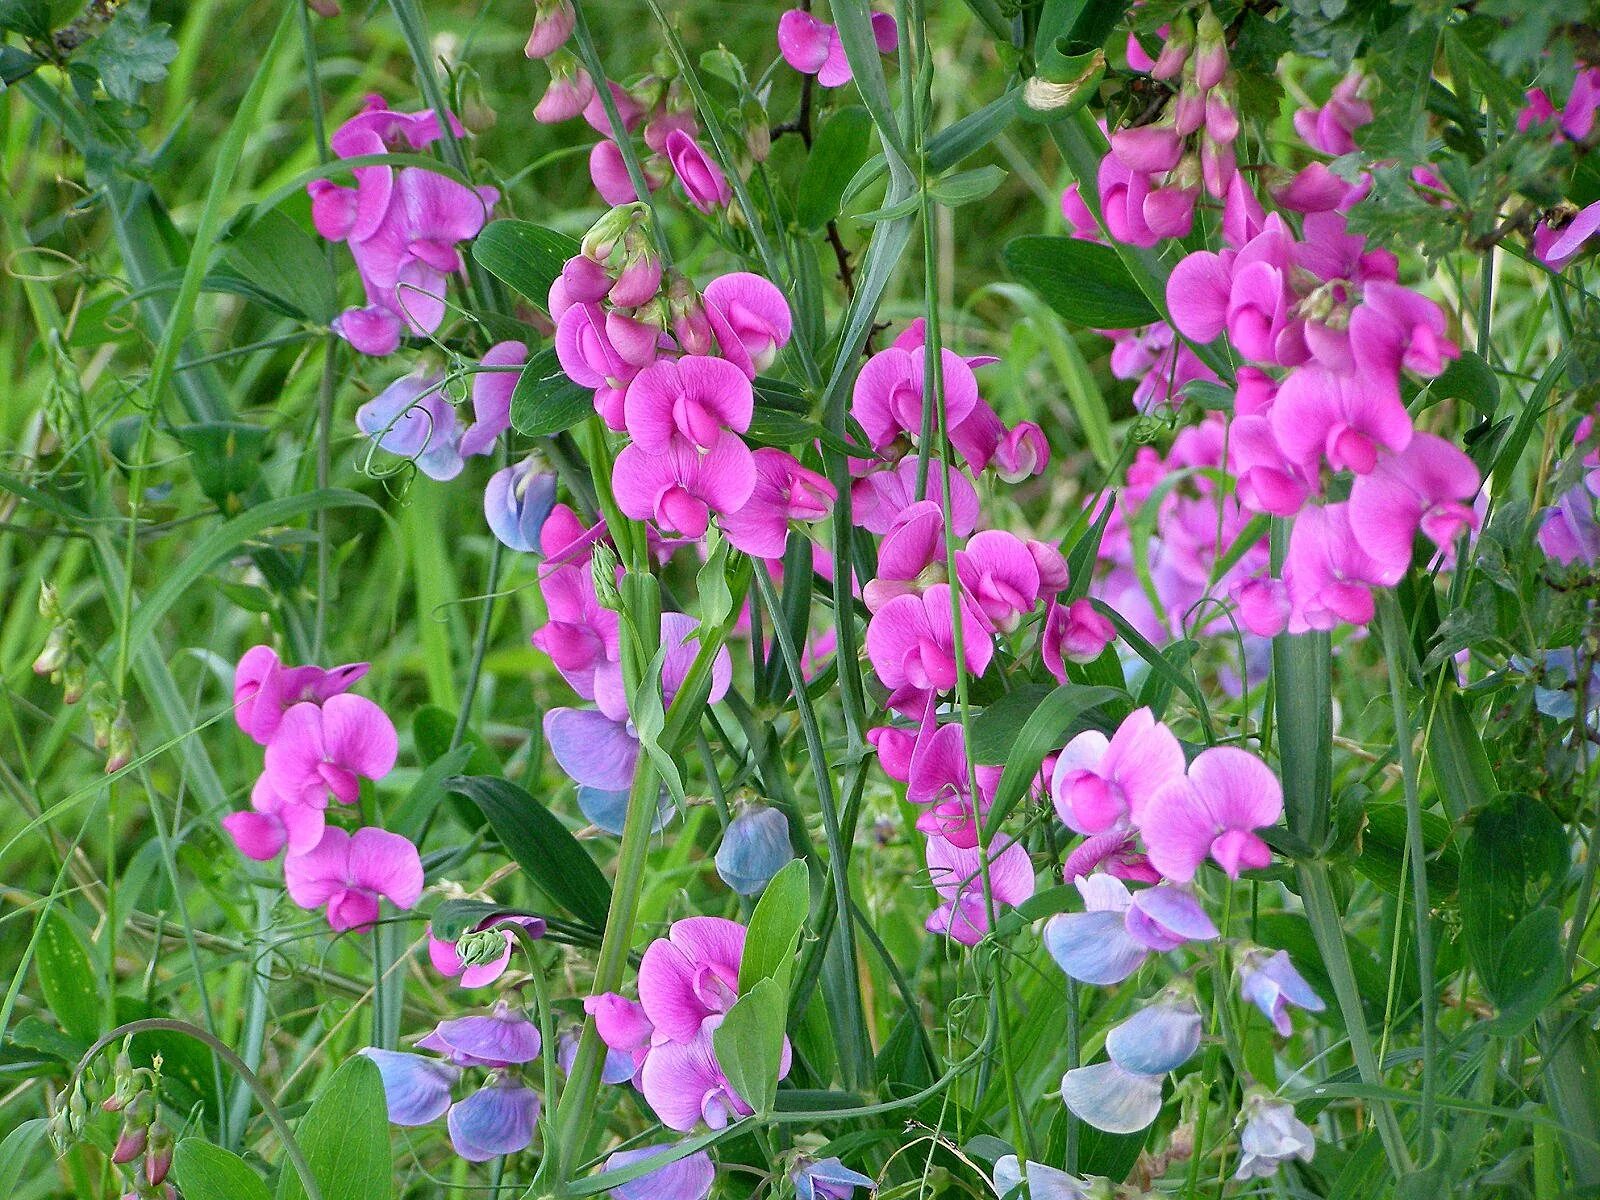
[1283,504,1405,634]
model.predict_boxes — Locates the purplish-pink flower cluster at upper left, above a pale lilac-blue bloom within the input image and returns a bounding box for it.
[306,96,499,355]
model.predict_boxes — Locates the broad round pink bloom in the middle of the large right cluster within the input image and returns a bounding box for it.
[1272,366,1411,475]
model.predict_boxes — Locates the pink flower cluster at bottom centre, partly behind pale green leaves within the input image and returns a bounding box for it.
[584,917,789,1133]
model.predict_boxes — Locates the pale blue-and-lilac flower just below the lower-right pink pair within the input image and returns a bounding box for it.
[1045,874,1218,987]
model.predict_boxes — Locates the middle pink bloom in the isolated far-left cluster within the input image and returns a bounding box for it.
[266,694,400,808]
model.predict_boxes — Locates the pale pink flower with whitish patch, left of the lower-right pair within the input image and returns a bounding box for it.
[1050,709,1184,834]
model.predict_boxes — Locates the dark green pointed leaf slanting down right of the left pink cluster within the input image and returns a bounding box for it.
[445,776,611,930]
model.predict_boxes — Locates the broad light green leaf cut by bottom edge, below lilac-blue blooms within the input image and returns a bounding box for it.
[277,1054,394,1200]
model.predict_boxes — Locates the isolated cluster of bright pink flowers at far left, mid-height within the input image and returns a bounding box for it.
[222,646,422,931]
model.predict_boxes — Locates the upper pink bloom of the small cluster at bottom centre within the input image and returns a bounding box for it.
[638,917,744,1043]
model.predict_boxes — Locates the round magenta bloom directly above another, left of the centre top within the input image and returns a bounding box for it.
[622,355,755,454]
